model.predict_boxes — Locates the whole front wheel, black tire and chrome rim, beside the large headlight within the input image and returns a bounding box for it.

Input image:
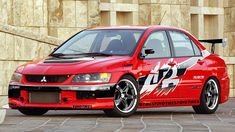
[104,76,140,117]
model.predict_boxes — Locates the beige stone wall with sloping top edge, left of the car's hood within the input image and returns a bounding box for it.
[0,25,61,95]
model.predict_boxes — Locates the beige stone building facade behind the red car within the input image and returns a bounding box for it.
[0,0,235,100]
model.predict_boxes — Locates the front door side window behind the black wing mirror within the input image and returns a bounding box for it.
[142,31,171,58]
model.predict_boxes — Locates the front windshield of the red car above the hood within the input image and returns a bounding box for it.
[52,29,143,55]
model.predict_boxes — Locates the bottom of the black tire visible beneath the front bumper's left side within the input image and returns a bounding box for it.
[18,108,48,116]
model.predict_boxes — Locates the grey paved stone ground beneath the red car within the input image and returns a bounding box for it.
[0,98,235,132]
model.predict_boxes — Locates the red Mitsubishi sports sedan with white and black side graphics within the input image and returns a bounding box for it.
[9,26,229,116]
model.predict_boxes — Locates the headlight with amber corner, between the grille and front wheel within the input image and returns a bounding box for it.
[72,73,111,82]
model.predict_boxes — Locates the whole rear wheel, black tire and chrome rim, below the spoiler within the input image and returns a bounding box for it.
[193,78,220,114]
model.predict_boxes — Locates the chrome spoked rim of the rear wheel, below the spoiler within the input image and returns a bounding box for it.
[205,79,219,110]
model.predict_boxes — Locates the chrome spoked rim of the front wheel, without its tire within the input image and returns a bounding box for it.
[114,79,137,113]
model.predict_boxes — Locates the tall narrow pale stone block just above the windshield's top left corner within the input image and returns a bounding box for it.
[76,1,88,27]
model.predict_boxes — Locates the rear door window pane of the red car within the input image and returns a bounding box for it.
[169,31,194,57]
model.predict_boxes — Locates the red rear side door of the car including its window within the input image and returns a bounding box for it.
[168,31,206,100]
